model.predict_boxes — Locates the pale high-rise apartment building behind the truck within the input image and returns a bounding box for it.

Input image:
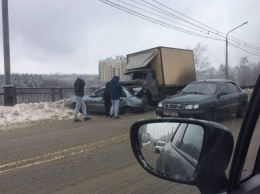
[99,55,126,81]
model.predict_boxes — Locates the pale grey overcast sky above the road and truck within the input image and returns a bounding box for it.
[0,0,260,74]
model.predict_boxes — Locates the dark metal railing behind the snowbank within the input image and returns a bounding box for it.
[0,87,98,106]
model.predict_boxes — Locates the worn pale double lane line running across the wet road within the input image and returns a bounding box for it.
[0,134,129,174]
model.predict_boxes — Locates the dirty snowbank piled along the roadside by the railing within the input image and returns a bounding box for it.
[0,99,73,130]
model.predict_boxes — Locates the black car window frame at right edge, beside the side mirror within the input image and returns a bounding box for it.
[227,75,260,192]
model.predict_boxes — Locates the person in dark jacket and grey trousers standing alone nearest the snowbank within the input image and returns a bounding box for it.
[74,75,91,122]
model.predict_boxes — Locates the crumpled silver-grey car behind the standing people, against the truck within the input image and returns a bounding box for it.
[68,87,147,114]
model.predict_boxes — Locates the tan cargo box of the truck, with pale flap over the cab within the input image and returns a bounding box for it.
[126,47,196,86]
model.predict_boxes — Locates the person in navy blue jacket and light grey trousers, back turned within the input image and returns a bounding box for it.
[109,76,123,119]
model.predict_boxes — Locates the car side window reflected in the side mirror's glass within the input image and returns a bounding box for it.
[180,124,204,161]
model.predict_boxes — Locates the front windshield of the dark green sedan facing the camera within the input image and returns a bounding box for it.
[182,82,217,94]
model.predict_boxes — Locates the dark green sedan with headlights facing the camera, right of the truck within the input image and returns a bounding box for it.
[156,79,248,121]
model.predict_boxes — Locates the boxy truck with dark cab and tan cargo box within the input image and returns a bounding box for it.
[120,47,196,106]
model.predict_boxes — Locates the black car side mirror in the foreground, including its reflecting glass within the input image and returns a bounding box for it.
[130,118,234,193]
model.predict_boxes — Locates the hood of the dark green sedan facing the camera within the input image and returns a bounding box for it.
[161,93,212,103]
